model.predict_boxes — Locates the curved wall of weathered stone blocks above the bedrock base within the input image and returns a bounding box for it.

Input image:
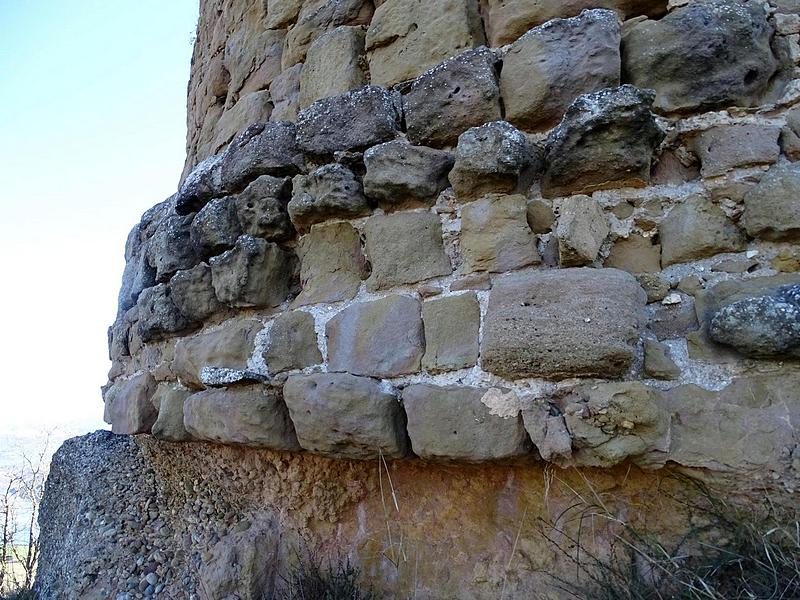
[104,0,800,482]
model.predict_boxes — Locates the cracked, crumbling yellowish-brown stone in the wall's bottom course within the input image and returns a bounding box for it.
[562,382,671,467]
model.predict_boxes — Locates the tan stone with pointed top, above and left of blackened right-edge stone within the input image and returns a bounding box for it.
[658,196,747,267]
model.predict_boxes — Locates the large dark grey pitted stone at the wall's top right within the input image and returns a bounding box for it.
[622,0,776,112]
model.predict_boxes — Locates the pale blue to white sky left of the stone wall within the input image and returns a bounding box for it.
[0,0,198,435]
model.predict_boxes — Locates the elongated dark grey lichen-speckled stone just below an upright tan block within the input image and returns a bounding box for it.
[297,85,400,156]
